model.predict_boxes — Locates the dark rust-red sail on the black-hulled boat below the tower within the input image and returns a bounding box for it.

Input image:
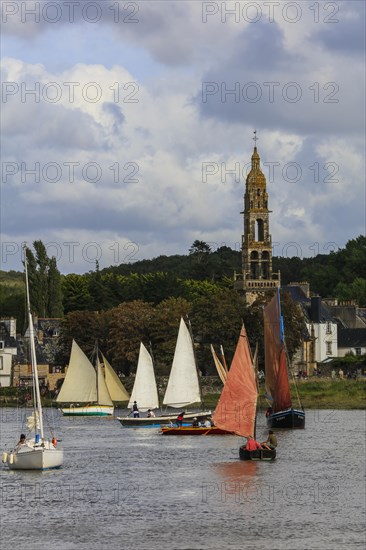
[264,295,291,412]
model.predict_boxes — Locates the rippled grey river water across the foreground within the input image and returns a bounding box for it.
[0,409,365,550]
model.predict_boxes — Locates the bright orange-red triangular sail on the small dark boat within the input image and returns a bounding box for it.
[213,325,258,437]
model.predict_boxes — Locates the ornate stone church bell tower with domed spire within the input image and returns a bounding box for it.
[234,132,280,304]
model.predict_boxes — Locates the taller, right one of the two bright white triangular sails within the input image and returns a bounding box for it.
[163,318,201,408]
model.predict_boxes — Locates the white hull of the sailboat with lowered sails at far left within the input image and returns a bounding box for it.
[3,441,63,470]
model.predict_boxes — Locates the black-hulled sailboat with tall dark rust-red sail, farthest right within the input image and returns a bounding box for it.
[264,289,305,428]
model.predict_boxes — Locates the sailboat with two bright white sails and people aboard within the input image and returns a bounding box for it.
[118,318,211,427]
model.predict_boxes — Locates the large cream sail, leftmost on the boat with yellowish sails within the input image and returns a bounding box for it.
[56,340,97,403]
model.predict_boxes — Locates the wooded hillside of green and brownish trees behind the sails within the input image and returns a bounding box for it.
[0,236,366,374]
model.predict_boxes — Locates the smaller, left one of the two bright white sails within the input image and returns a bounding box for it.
[128,342,159,411]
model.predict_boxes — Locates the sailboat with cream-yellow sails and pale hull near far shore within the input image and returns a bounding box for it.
[56,340,130,416]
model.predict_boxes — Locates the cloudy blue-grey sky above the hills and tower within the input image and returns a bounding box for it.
[1,0,366,274]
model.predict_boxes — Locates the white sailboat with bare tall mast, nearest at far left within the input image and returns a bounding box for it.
[2,245,63,470]
